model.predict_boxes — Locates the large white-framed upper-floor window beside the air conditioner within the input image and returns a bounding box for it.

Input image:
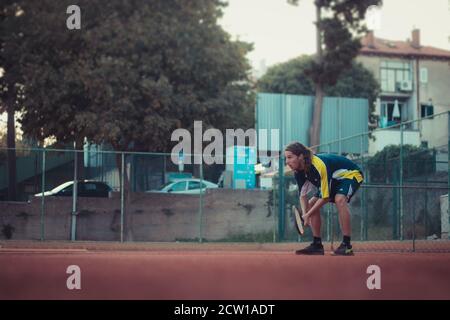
[380,61,412,92]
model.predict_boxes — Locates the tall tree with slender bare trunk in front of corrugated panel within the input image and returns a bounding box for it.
[287,0,381,146]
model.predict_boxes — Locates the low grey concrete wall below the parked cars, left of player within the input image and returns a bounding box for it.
[0,189,274,241]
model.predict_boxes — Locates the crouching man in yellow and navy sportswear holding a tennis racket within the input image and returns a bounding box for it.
[284,142,363,256]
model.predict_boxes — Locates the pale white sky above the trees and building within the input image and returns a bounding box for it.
[219,0,450,69]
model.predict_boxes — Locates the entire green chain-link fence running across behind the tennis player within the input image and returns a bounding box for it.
[0,113,450,252]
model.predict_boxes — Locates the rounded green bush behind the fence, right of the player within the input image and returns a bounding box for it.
[367,144,435,182]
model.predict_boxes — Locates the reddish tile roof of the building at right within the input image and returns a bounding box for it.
[360,35,450,60]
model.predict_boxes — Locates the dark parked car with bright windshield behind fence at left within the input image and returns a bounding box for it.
[34,180,112,198]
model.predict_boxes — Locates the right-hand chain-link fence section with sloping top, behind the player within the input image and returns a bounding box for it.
[275,112,450,251]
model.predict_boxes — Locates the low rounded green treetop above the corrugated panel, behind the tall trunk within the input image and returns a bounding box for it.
[257,56,379,122]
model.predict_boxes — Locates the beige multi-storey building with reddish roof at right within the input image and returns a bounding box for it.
[357,29,450,154]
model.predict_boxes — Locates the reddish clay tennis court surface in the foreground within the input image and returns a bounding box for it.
[0,241,450,300]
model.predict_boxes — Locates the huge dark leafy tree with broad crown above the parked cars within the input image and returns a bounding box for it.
[7,0,254,239]
